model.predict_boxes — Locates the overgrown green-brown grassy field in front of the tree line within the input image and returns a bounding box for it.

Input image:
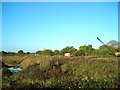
[2,55,119,89]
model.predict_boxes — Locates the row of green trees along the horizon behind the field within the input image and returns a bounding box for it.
[0,40,120,56]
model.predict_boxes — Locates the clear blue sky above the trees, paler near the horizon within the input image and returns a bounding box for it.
[2,2,118,52]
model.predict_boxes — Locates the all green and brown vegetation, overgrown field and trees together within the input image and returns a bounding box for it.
[0,41,120,90]
